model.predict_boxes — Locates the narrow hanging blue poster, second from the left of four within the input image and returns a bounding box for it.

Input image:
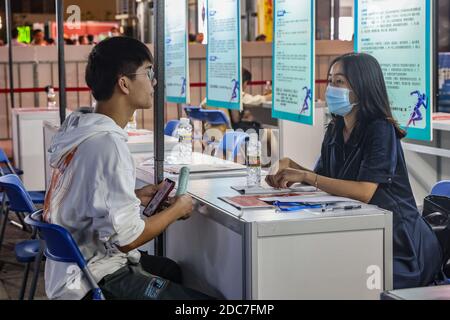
[206,0,241,110]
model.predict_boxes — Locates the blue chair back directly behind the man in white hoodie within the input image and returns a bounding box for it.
[25,210,105,300]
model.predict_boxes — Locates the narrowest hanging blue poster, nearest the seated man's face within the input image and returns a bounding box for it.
[164,0,190,103]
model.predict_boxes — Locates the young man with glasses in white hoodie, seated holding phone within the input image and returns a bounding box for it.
[44,37,206,299]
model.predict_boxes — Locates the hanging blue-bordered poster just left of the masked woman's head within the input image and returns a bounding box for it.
[272,0,315,125]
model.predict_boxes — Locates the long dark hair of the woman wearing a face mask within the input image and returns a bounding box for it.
[328,53,406,139]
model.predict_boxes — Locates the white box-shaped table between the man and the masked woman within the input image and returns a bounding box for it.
[138,177,392,299]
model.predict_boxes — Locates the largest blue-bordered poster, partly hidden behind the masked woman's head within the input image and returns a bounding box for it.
[355,0,434,141]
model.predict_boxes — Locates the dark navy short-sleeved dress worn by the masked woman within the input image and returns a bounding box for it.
[314,118,441,288]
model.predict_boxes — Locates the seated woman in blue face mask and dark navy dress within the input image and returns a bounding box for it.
[266,54,442,289]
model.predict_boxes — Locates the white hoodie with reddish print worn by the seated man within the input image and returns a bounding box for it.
[44,112,144,299]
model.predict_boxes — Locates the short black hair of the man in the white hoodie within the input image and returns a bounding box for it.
[85,37,153,101]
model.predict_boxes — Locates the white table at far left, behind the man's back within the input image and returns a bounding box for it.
[12,108,59,191]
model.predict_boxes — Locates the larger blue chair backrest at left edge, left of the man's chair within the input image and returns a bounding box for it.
[0,174,36,213]
